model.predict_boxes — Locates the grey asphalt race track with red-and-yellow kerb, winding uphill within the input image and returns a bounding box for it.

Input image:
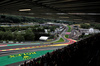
[0,27,74,66]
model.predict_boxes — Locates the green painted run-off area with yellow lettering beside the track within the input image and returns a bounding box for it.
[0,50,53,66]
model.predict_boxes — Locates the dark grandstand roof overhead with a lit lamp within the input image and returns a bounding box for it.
[0,0,100,22]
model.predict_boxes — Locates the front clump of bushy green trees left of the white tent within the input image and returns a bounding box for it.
[0,29,35,41]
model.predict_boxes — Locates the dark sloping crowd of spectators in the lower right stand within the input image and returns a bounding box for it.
[20,34,100,66]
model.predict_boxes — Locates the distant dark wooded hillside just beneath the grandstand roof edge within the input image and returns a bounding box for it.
[0,15,77,25]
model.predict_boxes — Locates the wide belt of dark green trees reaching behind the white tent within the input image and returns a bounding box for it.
[0,25,58,41]
